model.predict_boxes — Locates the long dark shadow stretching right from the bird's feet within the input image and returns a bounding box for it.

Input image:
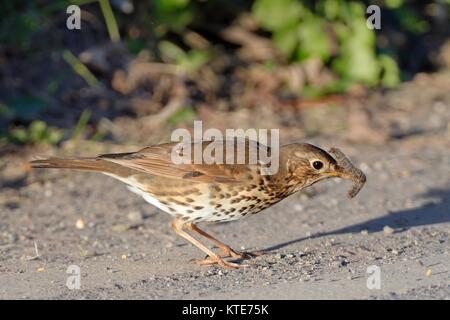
[264,189,450,251]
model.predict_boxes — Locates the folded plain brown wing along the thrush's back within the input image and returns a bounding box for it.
[99,139,268,184]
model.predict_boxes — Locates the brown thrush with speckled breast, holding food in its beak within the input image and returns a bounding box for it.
[30,138,366,269]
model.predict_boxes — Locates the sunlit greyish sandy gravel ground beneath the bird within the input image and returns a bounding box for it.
[0,132,450,299]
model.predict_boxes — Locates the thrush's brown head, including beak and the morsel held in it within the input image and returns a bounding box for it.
[283,143,366,198]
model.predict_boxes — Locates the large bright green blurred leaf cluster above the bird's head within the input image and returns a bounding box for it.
[252,0,399,87]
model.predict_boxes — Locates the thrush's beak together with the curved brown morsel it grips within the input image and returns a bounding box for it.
[328,148,366,198]
